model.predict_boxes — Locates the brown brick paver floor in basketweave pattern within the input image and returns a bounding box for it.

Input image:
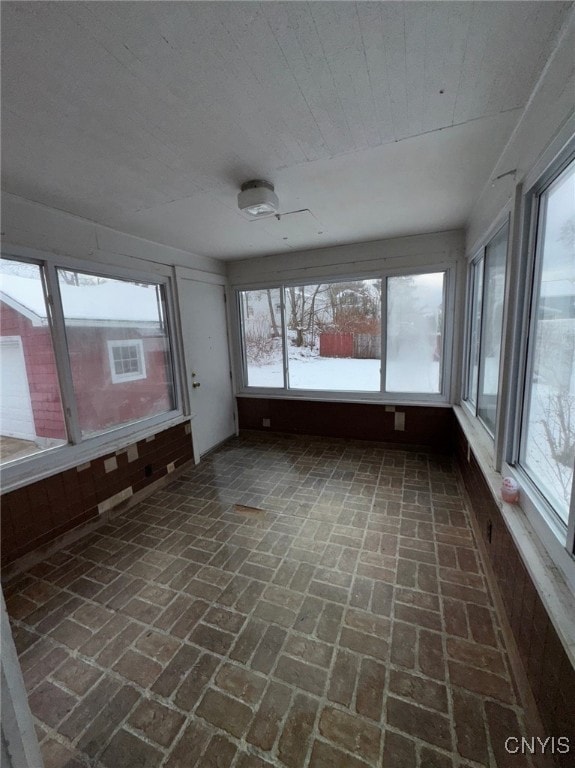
[6,434,544,768]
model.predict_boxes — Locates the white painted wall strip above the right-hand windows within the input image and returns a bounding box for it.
[466,8,575,254]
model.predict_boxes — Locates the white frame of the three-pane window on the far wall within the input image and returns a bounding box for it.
[231,260,457,406]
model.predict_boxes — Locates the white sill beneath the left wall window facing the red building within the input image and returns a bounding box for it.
[0,411,192,494]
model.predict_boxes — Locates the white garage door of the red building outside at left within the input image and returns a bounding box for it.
[0,336,36,440]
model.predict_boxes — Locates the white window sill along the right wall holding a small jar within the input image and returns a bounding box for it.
[453,406,575,666]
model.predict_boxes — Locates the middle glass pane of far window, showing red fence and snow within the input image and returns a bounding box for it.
[285,280,381,392]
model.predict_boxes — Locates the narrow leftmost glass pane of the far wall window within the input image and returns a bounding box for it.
[239,288,284,388]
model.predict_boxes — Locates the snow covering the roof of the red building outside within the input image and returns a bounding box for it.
[0,274,159,325]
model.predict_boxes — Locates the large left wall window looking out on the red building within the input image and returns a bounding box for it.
[0,258,175,463]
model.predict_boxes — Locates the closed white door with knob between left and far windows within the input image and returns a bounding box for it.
[178,273,236,456]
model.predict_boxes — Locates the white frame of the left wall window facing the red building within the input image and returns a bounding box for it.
[0,246,184,492]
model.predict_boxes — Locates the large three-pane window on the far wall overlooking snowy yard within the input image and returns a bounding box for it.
[238,271,446,398]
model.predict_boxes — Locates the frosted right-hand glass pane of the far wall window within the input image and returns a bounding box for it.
[385,272,445,393]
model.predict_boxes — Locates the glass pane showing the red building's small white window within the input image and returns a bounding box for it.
[58,269,175,436]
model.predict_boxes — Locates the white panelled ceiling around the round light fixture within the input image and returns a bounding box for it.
[1,2,571,259]
